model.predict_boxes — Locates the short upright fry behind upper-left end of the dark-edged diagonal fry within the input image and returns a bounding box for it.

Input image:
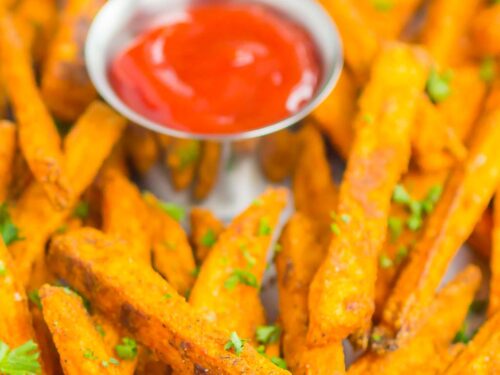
[102,170,151,264]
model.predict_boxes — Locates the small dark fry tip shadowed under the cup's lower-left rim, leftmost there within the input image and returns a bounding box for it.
[124,125,160,175]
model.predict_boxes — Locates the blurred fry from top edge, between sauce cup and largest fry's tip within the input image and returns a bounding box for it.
[320,0,380,82]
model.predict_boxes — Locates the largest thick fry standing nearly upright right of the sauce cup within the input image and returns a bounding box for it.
[307,44,427,347]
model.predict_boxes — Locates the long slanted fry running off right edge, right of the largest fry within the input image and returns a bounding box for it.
[383,100,500,337]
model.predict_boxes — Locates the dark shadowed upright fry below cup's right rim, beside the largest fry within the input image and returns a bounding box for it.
[293,125,337,226]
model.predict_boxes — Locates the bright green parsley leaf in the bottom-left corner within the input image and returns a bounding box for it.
[0,340,41,375]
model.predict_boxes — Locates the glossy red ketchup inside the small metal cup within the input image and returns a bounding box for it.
[109,3,321,134]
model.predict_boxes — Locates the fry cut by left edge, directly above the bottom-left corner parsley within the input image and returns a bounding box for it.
[0,236,39,347]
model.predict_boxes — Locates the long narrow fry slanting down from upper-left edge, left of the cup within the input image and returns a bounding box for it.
[0,13,72,208]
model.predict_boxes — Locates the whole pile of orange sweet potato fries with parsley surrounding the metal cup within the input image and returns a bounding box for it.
[0,0,500,375]
